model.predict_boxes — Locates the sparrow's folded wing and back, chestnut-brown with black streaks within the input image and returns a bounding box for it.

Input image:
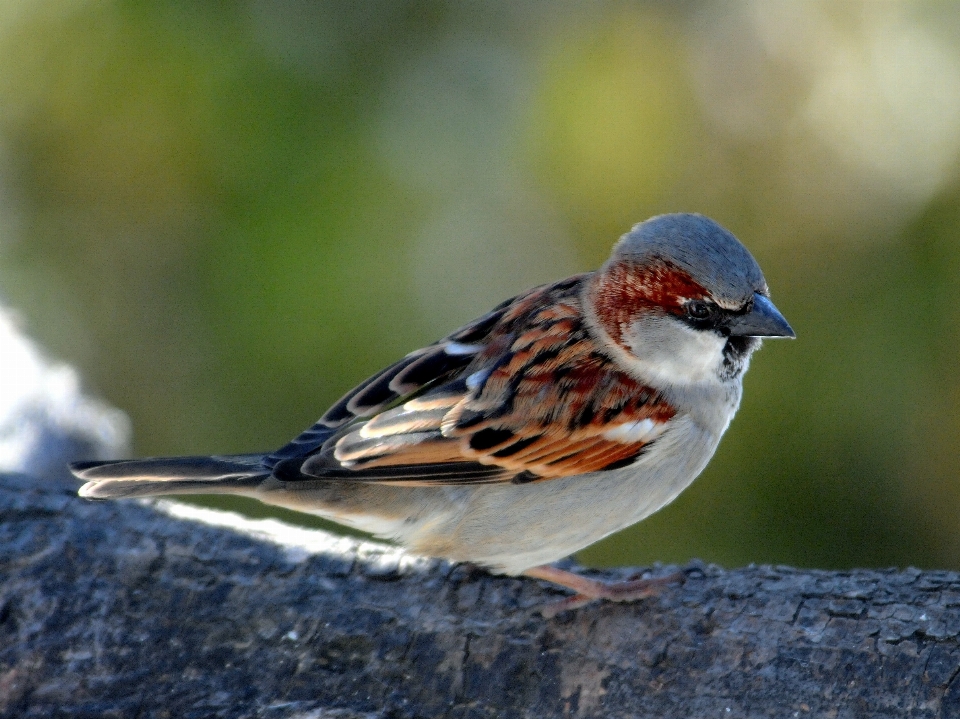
[272,276,675,485]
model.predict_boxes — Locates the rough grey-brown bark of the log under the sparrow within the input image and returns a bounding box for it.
[0,475,960,719]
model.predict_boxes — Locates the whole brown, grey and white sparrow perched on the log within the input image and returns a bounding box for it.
[71,214,795,615]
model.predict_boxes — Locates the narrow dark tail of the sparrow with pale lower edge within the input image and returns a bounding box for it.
[70,454,270,499]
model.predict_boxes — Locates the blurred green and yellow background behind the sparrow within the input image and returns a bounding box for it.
[0,0,960,569]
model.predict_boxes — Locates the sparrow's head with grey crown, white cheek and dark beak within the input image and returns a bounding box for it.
[585,214,795,386]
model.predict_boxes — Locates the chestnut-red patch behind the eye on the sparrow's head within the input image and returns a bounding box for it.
[593,260,707,347]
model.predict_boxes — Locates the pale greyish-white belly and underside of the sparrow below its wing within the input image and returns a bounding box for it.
[255,419,720,574]
